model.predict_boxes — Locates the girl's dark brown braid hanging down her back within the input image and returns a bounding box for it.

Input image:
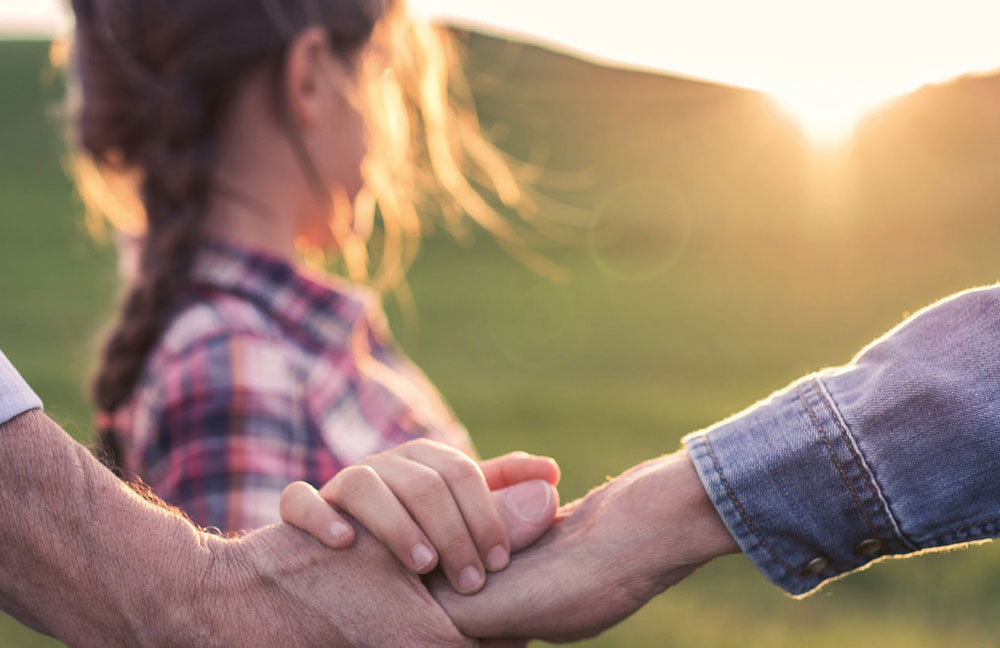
[94,85,214,412]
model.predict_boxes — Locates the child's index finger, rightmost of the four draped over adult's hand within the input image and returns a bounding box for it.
[400,442,510,571]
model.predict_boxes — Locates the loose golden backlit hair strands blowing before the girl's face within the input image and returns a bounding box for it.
[320,12,559,298]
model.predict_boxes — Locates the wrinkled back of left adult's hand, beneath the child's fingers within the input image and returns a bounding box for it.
[221,525,478,648]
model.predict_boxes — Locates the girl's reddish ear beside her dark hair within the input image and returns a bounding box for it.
[283,27,331,130]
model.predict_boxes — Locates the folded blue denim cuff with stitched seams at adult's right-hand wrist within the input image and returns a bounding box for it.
[684,375,913,596]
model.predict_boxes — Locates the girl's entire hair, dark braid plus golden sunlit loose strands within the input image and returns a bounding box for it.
[69,0,552,412]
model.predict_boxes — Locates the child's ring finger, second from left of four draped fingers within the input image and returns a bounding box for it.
[319,465,438,574]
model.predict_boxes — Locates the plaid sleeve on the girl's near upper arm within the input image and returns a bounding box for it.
[132,334,309,533]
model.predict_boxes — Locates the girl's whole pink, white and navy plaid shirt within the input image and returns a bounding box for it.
[102,244,471,531]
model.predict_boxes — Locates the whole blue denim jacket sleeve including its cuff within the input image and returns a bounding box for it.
[684,286,1000,595]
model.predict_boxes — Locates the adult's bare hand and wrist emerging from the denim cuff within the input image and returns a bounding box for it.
[431,450,738,642]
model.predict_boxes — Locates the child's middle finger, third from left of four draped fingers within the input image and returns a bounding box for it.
[365,454,488,594]
